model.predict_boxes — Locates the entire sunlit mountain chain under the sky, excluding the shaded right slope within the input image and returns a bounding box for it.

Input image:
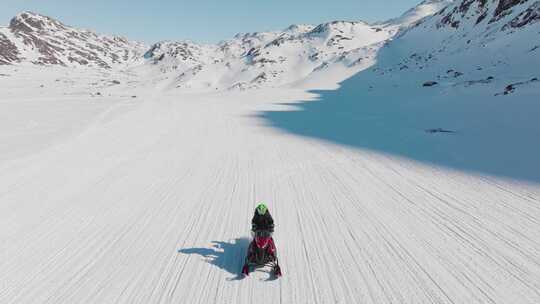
[0,0,454,90]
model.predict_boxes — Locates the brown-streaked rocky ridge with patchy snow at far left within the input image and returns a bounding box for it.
[0,12,147,68]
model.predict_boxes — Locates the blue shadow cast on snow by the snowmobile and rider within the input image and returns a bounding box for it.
[178,237,250,281]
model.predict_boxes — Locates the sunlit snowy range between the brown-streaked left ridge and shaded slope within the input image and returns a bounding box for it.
[141,0,451,90]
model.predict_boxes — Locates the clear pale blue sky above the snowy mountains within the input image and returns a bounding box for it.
[0,0,421,43]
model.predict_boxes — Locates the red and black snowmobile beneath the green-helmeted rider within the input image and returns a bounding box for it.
[242,230,281,277]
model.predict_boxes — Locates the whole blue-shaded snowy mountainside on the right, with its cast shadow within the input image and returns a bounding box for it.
[263,0,540,182]
